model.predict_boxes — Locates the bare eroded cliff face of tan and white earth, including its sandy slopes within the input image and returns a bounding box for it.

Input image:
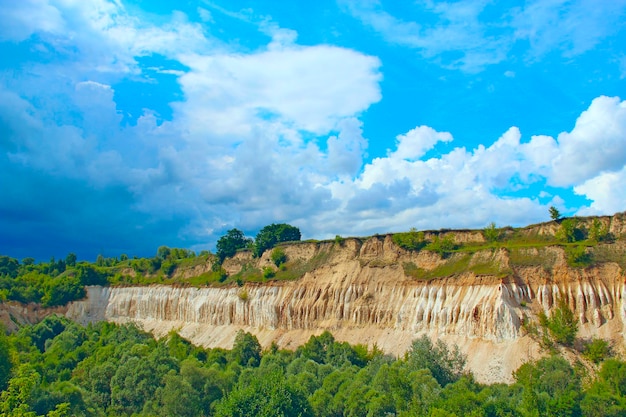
[67,224,626,382]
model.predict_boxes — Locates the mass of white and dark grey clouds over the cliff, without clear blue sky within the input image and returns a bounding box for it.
[0,0,626,258]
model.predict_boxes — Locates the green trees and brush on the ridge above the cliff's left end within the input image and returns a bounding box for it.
[0,224,301,307]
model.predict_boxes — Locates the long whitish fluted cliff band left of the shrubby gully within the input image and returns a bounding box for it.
[67,276,520,341]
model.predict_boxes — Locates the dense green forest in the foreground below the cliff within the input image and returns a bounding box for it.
[0,316,626,417]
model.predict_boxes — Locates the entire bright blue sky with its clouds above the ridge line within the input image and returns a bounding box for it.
[0,0,626,259]
